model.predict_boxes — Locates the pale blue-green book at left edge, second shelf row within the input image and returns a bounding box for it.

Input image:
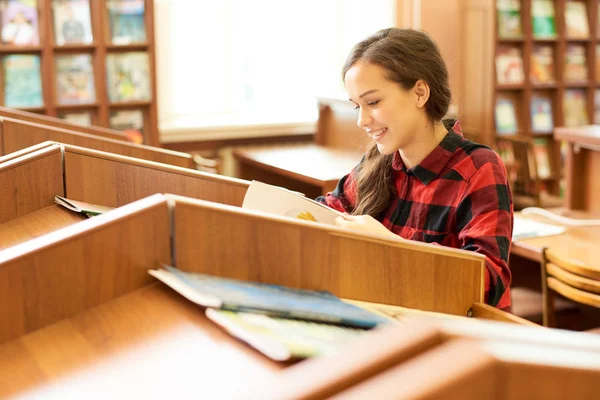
[2,54,44,108]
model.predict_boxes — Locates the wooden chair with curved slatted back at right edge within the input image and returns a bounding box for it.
[541,247,600,327]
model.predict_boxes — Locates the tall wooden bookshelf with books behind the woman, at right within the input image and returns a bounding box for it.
[463,0,600,207]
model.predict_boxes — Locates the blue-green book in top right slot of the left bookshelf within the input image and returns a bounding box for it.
[106,0,146,45]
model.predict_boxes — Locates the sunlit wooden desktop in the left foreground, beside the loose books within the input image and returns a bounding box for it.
[0,284,285,398]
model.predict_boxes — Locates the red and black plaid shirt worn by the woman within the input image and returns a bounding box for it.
[317,121,513,309]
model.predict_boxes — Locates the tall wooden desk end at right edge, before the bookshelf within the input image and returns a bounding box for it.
[554,125,600,212]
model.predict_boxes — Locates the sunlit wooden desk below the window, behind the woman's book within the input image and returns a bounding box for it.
[233,144,363,198]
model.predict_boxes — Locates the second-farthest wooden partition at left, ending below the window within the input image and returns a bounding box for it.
[0,117,195,169]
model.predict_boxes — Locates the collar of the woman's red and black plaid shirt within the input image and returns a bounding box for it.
[392,128,462,185]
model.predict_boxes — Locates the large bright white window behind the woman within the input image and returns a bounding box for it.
[155,0,396,141]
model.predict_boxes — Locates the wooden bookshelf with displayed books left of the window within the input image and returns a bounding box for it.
[0,0,160,146]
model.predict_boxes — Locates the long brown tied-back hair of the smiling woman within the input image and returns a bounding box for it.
[342,28,451,218]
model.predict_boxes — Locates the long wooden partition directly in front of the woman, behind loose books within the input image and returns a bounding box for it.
[172,196,485,315]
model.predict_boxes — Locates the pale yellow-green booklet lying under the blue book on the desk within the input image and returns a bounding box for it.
[206,308,369,361]
